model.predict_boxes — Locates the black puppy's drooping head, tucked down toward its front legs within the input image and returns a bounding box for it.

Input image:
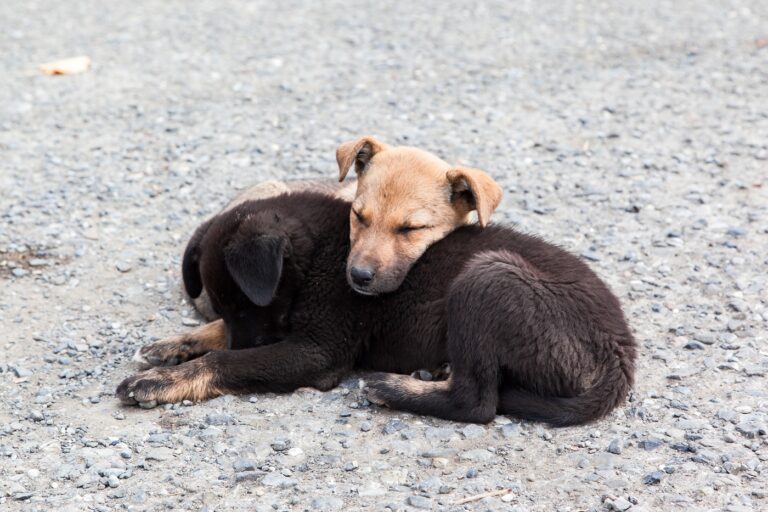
[183,208,297,349]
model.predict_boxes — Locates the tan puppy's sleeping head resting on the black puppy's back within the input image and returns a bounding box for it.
[336,137,501,295]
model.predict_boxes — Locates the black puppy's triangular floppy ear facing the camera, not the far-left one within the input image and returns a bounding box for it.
[224,236,287,306]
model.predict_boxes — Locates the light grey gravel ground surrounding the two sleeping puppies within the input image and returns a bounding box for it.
[0,0,768,512]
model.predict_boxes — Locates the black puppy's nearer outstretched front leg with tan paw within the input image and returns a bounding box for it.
[117,339,351,404]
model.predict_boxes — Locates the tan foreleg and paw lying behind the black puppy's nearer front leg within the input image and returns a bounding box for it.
[133,320,227,368]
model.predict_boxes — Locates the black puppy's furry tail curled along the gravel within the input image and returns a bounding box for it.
[498,350,634,427]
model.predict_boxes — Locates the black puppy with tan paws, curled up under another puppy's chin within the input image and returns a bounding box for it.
[117,193,635,426]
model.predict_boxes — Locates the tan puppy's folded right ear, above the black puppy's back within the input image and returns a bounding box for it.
[446,167,501,227]
